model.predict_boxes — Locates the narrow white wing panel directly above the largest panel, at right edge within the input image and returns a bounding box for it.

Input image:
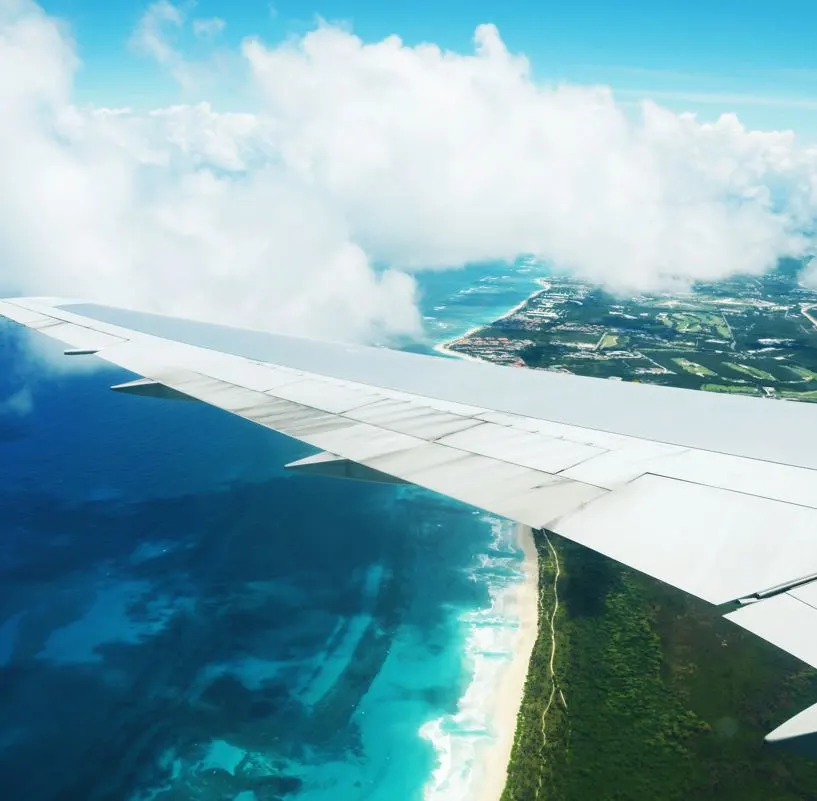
[650,450,817,507]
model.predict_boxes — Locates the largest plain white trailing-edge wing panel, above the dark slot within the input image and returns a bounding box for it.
[553,475,817,604]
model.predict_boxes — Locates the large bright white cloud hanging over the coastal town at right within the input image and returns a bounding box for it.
[244,25,815,289]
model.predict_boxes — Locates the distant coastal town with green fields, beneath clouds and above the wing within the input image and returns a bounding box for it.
[445,264,817,401]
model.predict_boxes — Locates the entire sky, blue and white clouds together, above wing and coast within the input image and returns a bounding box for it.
[6,0,817,341]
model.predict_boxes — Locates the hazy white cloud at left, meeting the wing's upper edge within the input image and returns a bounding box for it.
[0,0,419,339]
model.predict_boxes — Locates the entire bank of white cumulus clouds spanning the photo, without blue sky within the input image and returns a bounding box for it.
[0,0,817,348]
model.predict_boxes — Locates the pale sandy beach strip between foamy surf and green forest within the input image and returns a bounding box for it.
[473,523,539,801]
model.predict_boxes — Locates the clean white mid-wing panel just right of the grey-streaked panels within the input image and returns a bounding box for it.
[440,423,603,473]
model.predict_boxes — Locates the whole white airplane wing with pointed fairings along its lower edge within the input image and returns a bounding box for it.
[0,298,817,744]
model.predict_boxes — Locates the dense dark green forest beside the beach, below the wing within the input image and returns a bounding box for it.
[502,535,817,801]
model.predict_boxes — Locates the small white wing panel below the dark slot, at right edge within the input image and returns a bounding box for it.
[725,593,817,667]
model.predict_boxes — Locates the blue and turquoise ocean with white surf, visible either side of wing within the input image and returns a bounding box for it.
[0,264,548,801]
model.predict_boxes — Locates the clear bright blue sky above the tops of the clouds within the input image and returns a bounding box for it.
[42,0,817,138]
